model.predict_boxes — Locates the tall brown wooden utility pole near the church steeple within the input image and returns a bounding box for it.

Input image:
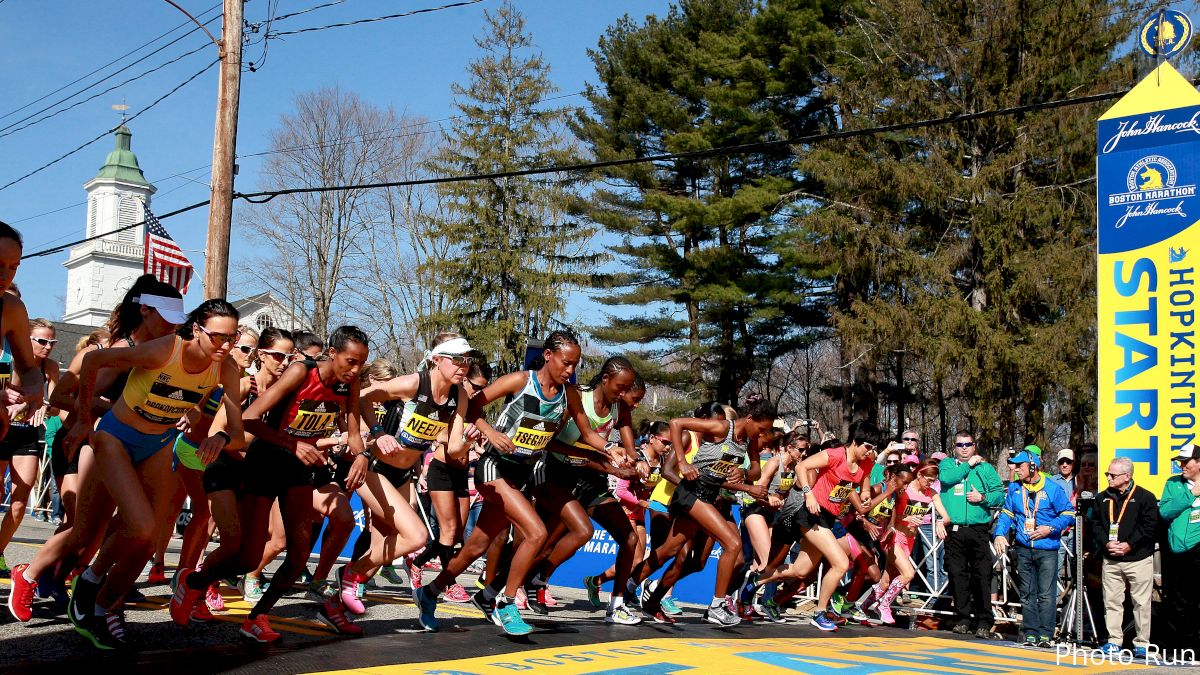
[204,0,245,299]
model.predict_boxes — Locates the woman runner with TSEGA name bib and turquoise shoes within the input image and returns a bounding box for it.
[413,330,605,635]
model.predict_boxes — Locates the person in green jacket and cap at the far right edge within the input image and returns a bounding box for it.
[1158,443,1200,650]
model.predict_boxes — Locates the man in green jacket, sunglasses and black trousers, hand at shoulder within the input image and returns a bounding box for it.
[937,431,1004,639]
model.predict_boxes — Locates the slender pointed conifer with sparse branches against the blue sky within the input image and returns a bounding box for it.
[420,1,600,374]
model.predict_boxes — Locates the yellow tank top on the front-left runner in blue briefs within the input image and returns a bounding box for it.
[121,335,221,424]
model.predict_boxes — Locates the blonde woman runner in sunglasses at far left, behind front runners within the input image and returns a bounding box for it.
[0,318,59,577]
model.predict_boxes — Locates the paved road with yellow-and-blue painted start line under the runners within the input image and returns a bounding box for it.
[0,521,1200,675]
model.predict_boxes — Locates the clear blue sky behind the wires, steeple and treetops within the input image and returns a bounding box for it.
[0,0,670,319]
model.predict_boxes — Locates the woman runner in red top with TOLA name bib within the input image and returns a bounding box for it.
[170,325,370,643]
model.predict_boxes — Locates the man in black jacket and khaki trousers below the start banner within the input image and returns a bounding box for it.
[1097,458,1158,658]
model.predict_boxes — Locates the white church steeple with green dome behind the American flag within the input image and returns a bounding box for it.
[62,124,155,325]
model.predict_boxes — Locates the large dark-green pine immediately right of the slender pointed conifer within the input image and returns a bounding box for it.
[575,0,841,401]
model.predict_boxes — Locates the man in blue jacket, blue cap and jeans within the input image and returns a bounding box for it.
[992,450,1075,647]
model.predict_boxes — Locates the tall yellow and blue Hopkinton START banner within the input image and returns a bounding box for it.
[1096,62,1200,495]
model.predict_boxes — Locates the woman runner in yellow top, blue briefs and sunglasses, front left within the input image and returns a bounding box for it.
[66,299,244,649]
